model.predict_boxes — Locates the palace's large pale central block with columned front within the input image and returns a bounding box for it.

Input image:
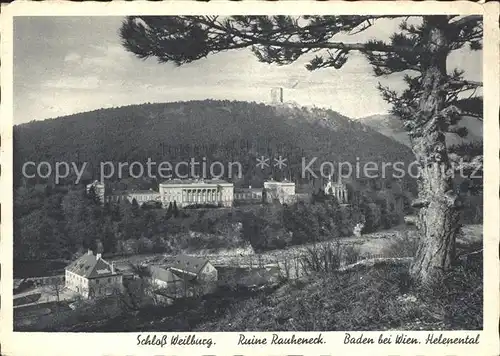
[159,179,234,208]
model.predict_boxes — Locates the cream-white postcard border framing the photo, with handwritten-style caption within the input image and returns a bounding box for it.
[0,1,500,356]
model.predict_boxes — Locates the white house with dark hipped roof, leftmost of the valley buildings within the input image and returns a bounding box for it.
[65,250,123,298]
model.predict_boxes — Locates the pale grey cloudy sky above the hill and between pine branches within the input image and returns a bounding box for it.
[14,16,482,124]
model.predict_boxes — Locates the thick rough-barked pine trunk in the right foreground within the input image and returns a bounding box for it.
[410,16,460,284]
